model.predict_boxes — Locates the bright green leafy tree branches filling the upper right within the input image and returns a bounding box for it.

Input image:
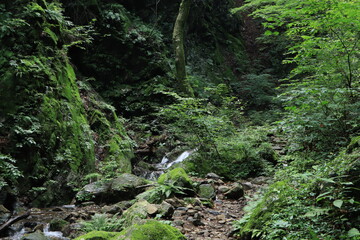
[236,0,360,154]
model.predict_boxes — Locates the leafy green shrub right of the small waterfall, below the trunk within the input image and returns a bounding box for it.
[160,90,276,179]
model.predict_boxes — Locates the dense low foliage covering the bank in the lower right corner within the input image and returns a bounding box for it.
[235,137,360,239]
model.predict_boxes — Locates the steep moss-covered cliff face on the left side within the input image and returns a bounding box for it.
[0,1,132,205]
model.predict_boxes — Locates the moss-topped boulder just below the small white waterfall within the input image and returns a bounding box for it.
[158,168,193,189]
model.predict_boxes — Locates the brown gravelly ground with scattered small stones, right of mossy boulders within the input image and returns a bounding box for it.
[172,177,269,240]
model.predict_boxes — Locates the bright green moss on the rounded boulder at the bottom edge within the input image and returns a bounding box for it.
[115,220,186,240]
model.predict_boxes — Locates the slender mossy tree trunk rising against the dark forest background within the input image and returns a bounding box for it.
[173,0,194,96]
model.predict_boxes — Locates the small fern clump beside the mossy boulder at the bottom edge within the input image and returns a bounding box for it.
[81,214,124,233]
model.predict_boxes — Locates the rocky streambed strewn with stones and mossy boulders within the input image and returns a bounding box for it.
[2,168,267,240]
